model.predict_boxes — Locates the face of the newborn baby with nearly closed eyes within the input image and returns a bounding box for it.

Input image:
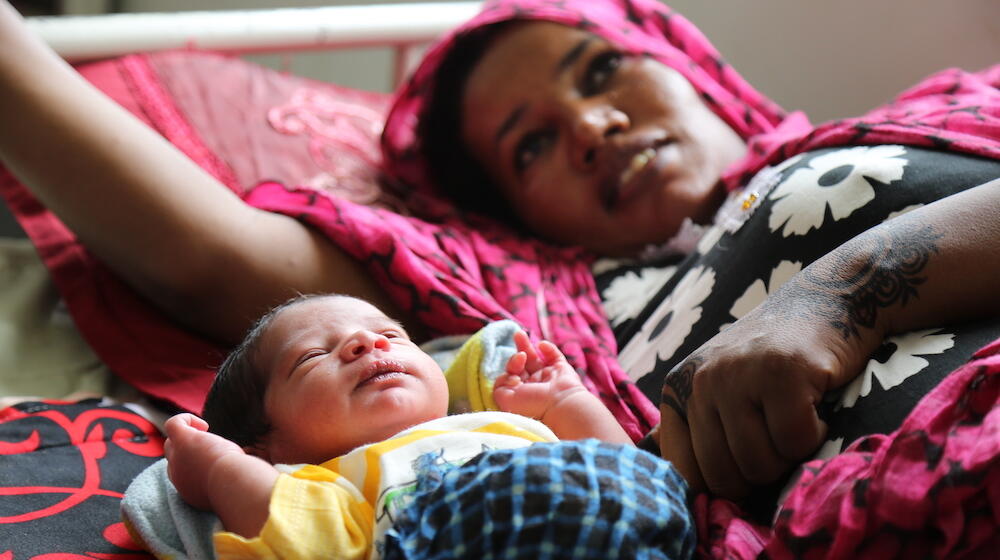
[258,296,448,463]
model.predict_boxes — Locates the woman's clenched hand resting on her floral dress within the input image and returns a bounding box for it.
[660,294,868,499]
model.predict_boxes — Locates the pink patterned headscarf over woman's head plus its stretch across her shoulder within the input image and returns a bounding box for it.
[382,0,1000,197]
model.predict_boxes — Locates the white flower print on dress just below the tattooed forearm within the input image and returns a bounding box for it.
[840,329,955,408]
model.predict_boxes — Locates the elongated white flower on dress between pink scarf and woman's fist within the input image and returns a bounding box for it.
[618,266,715,381]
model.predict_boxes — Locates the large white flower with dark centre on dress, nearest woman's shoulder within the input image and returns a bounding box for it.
[768,146,907,237]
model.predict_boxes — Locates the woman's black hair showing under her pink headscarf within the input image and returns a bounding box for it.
[417,21,521,227]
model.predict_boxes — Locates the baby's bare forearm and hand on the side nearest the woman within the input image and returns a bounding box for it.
[493,331,632,443]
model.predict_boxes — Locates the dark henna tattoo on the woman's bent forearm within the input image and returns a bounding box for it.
[769,220,943,340]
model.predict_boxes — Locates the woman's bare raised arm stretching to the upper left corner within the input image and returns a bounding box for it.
[0,0,410,341]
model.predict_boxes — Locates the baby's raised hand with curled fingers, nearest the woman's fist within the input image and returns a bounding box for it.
[493,331,587,420]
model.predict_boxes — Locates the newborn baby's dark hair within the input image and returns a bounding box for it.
[201,294,332,447]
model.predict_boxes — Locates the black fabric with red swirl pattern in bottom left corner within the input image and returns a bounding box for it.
[0,400,163,560]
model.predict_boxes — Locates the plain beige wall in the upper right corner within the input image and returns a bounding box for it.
[669,0,1000,122]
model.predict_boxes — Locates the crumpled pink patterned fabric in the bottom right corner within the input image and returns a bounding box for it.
[695,340,1000,560]
